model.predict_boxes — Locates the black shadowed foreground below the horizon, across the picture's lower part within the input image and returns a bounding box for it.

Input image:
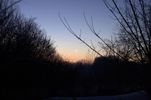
[0,59,147,100]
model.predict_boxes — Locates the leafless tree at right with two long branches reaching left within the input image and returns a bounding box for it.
[60,0,151,63]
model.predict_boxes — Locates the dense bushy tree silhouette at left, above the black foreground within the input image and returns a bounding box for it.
[0,0,56,61]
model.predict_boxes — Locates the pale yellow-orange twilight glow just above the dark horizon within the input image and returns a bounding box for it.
[57,45,95,62]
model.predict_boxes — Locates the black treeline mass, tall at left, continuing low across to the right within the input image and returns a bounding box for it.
[0,0,144,100]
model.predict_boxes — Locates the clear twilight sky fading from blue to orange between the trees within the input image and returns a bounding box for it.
[19,0,116,61]
